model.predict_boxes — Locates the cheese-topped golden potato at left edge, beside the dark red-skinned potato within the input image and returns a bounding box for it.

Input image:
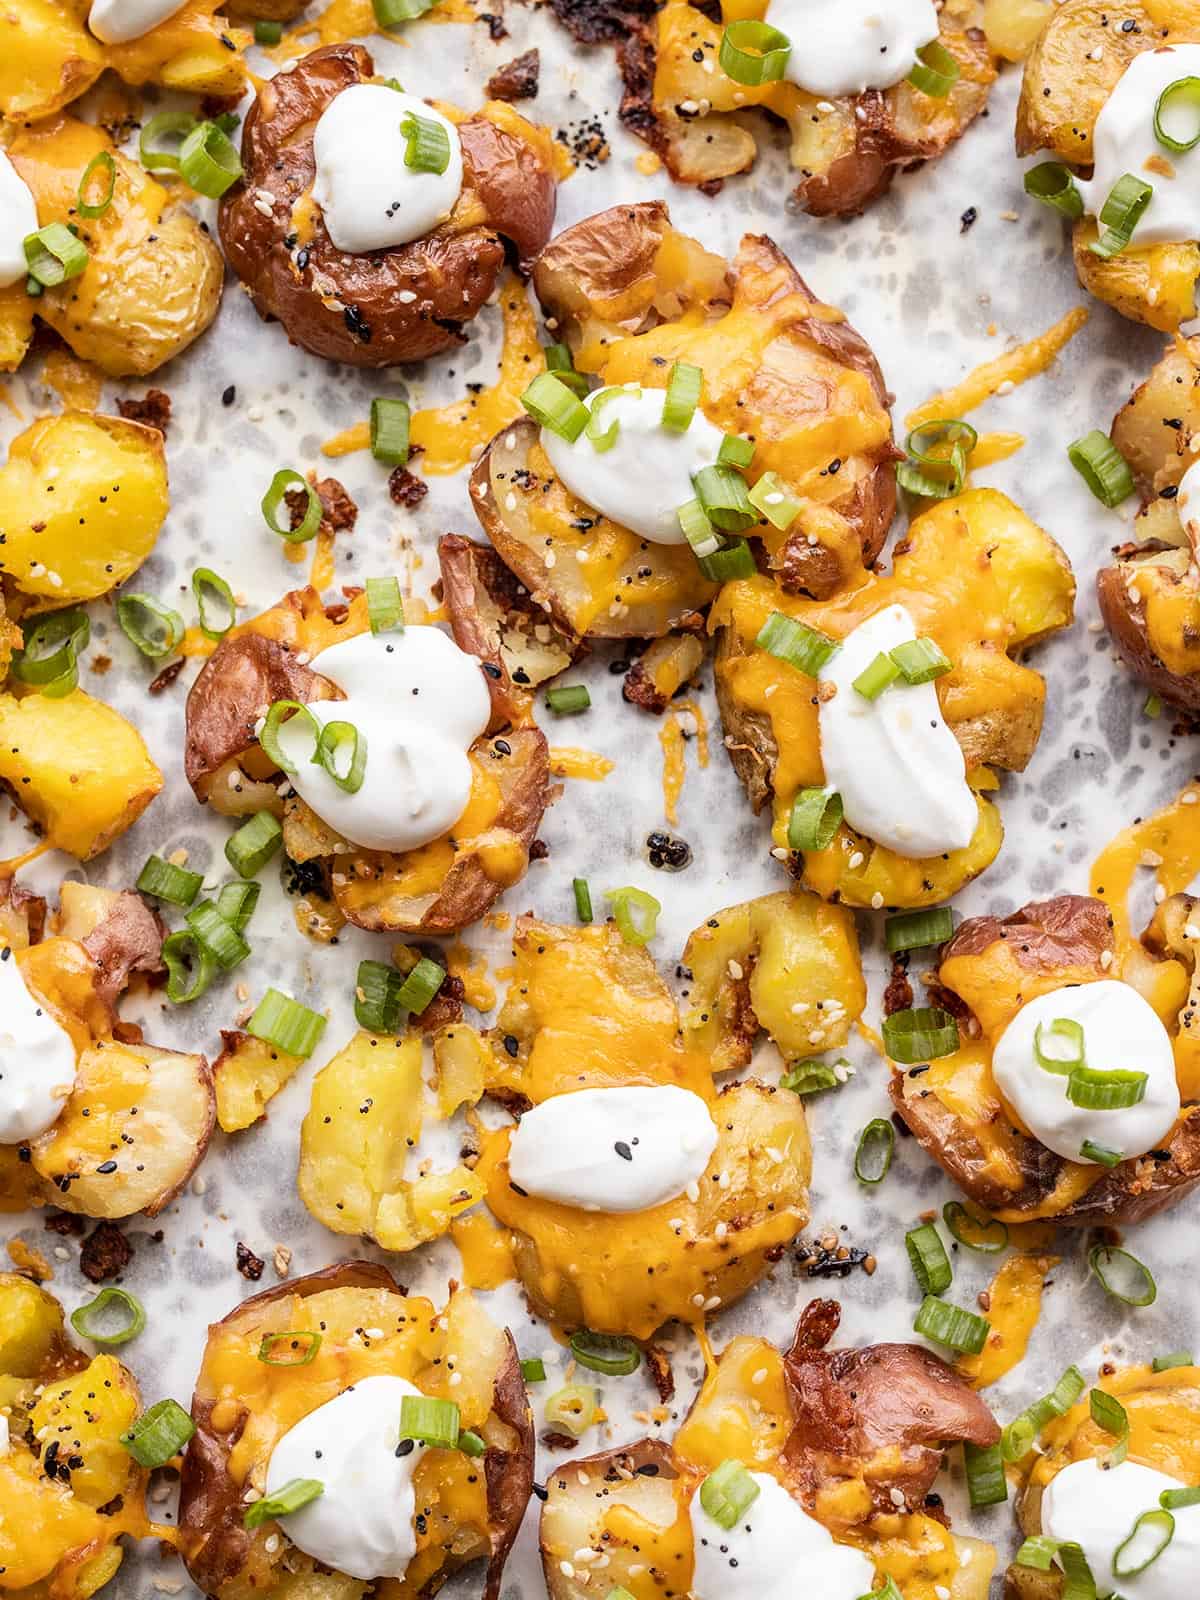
[0,114,224,378]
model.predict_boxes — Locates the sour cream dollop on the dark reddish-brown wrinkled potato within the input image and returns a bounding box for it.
[312,83,462,256]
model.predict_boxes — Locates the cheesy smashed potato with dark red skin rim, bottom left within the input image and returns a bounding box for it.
[179,1261,534,1600]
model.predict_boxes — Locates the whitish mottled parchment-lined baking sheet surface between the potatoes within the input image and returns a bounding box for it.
[0,6,1200,1600]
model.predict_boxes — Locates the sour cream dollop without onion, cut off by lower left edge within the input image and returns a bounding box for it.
[0,950,77,1144]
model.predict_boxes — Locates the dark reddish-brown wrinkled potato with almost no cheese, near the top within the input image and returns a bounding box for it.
[219,45,555,366]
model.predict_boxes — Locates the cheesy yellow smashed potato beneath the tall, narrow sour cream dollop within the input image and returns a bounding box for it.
[709,490,1075,907]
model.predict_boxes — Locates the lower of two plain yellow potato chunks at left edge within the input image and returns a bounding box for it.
[0,690,163,861]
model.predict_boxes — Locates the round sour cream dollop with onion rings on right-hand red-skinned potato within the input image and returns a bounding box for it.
[992,979,1179,1165]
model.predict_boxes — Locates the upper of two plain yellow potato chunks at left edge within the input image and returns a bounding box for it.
[0,411,170,606]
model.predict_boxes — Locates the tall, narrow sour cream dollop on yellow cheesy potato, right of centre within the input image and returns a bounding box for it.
[818,605,979,861]
